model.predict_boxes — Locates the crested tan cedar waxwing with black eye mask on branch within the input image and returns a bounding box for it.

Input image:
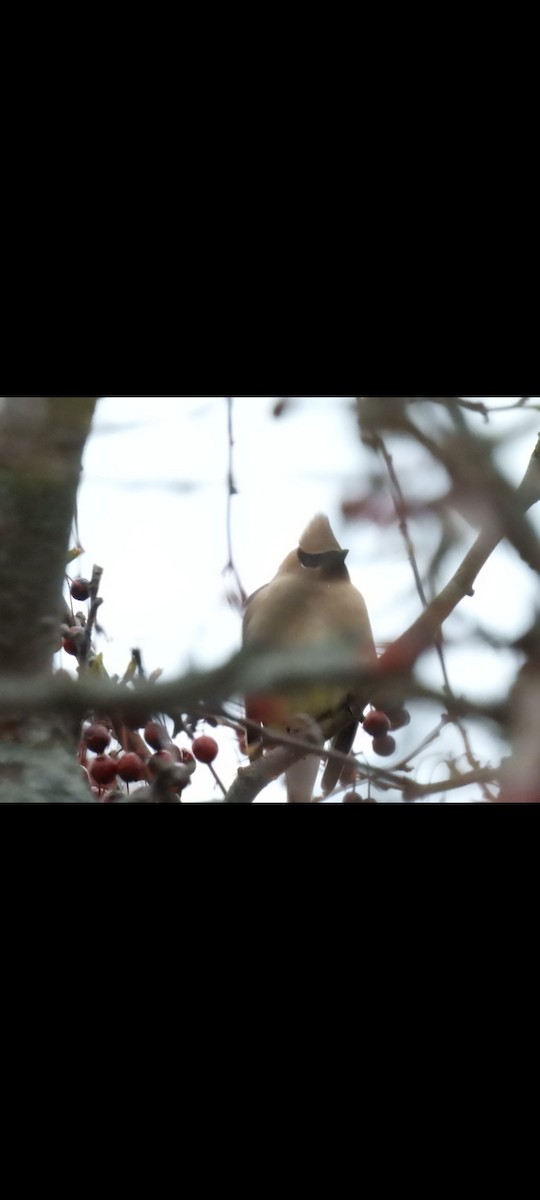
[242,514,377,803]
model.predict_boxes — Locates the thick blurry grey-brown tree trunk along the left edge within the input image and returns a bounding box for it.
[0,396,96,802]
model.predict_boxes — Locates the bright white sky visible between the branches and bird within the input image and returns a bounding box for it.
[68,397,540,800]
